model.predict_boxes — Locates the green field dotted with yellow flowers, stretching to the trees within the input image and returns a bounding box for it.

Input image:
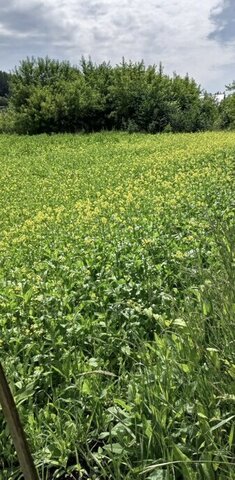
[0,132,235,480]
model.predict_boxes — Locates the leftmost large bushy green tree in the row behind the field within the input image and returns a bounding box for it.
[10,57,79,133]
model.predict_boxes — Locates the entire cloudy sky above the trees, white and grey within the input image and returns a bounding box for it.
[0,0,235,92]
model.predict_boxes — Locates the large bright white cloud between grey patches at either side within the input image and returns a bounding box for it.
[0,0,235,88]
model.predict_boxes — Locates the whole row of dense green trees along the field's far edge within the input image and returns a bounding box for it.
[0,58,235,134]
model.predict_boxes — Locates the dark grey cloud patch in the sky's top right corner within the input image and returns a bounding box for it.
[209,0,235,43]
